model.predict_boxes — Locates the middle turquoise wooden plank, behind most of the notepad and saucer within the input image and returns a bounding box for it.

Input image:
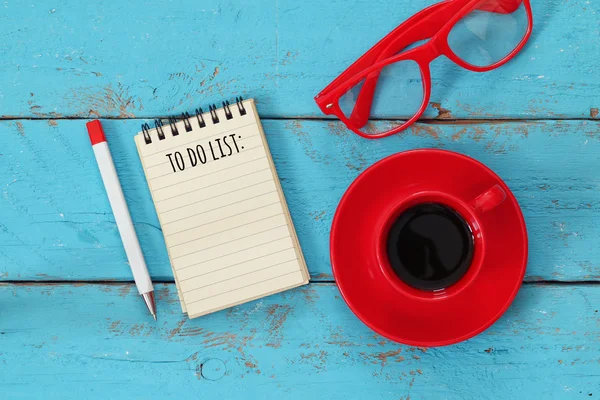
[0,120,600,281]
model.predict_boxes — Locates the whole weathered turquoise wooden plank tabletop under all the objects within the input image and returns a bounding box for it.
[0,0,600,400]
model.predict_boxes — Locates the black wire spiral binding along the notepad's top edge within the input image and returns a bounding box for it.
[142,96,247,144]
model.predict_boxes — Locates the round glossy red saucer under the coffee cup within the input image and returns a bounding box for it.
[330,150,527,346]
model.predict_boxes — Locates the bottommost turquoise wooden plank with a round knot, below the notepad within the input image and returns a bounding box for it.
[0,284,600,400]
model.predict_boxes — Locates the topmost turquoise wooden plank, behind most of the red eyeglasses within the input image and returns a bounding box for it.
[0,0,600,118]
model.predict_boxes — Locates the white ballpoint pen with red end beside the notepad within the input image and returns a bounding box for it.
[86,120,156,320]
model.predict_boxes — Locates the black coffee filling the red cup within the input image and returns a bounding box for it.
[387,203,474,290]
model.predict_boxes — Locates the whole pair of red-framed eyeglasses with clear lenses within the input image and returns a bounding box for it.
[315,0,533,139]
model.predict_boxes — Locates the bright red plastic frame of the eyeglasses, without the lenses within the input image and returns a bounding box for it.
[315,0,533,139]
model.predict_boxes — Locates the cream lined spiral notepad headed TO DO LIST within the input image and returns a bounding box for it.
[135,99,309,318]
